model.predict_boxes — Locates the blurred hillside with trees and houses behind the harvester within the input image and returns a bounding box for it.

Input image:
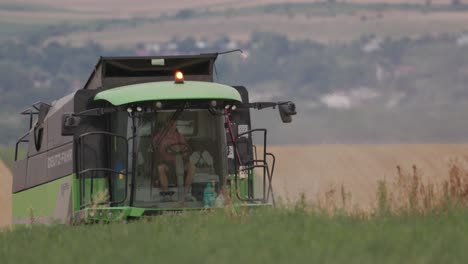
[0,0,468,146]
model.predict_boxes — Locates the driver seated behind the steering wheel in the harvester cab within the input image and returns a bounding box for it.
[153,116,195,200]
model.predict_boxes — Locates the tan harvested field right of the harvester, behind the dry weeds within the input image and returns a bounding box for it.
[269,144,468,209]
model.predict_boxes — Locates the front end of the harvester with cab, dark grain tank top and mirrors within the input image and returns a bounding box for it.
[62,55,295,214]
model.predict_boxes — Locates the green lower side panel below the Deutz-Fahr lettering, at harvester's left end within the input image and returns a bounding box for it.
[13,175,73,218]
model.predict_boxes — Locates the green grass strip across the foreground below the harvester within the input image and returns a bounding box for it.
[0,209,468,264]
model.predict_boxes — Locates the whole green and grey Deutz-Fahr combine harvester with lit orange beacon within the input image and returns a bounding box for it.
[13,54,296,224]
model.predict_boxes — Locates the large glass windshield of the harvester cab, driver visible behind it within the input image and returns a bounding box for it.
[129,110,227,208]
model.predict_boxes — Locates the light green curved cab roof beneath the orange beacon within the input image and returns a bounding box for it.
[94,81,242,106]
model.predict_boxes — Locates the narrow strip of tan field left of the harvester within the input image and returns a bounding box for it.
[0,161,11,229]
